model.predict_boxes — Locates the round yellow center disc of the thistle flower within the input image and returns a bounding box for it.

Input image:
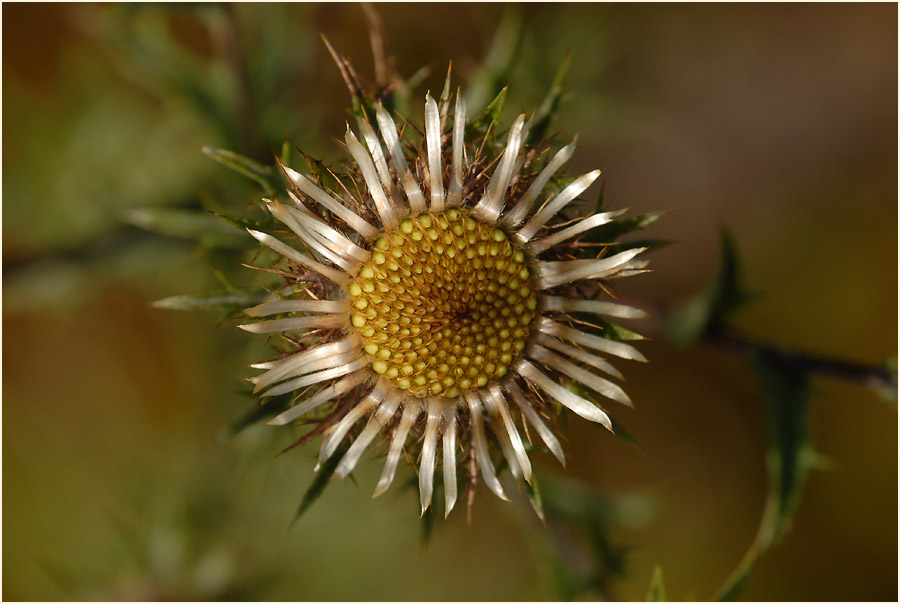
[348,209,537,398]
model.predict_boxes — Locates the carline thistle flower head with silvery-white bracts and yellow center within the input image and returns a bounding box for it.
[241,61,647,516]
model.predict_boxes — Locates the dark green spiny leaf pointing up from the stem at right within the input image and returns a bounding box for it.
[666,229,748,346]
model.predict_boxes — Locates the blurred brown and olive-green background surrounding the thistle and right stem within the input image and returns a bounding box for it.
[2,3,897,600]
